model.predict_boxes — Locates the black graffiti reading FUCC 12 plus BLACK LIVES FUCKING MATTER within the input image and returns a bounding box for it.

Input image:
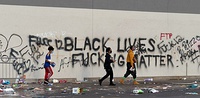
[29,35,173,71]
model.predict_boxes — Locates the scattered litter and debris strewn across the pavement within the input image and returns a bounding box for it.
[0,78,199,97]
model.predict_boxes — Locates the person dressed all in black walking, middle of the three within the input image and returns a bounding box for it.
[99,47,116,86]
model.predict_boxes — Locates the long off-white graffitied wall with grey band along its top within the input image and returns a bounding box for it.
[0,0,200,80]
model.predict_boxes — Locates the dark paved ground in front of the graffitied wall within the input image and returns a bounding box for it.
[0,80,200,98]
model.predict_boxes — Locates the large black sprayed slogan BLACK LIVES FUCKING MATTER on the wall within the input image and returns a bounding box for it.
[51,37,173,72]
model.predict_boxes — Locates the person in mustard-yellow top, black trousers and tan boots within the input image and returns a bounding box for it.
[120,46,139,85]
